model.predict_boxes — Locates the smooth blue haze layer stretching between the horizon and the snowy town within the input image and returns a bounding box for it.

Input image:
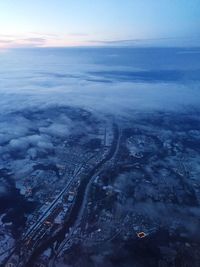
[0,48,200,115]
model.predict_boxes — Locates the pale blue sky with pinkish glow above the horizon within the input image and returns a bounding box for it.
[0,0,200,48]
